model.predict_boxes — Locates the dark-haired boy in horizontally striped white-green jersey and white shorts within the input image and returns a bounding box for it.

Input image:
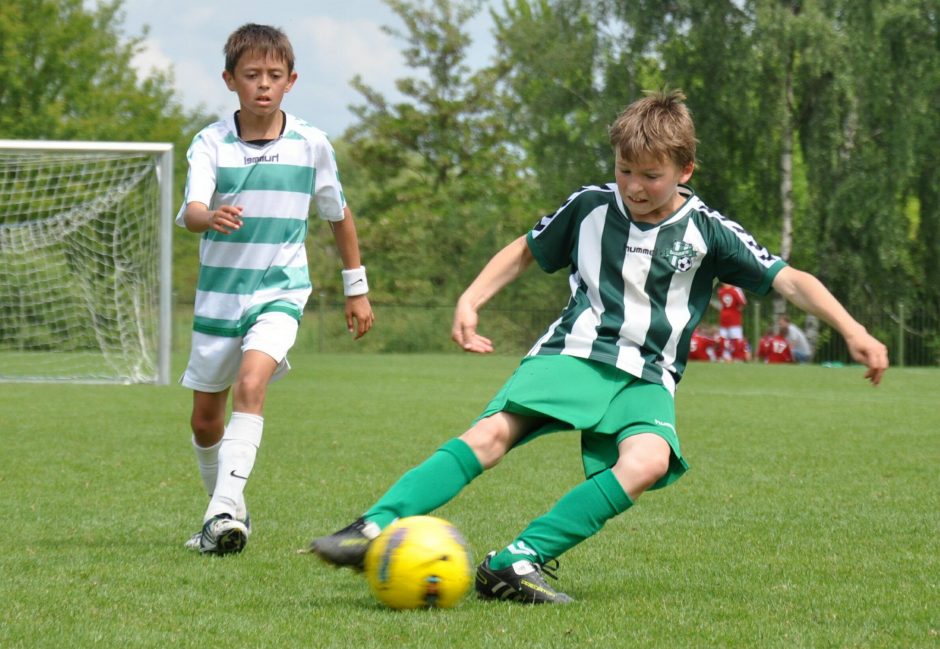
[176,24,374,554]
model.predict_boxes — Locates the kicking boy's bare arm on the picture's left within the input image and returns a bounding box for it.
[450,235,534,354]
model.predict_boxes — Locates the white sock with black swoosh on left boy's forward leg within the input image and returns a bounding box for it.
[203,412,264,521]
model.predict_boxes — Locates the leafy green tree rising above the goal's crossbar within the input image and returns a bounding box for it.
[0,0,195,142]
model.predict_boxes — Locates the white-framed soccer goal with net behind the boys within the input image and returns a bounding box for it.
[0,140,173,384]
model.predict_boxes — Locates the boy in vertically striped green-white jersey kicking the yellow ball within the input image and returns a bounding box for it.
[310,92,888,603]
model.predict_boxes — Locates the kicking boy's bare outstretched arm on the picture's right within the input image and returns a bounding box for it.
[774,266,888,385]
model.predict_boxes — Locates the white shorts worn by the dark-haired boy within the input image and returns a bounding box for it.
[180,311,298,392]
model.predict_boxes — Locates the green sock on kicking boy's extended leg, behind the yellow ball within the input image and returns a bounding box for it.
[363,438,483,529]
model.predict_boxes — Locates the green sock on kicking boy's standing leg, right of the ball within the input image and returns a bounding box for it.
[490,469,633,570]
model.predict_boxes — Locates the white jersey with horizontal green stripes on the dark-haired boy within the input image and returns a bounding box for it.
[176,113,346,336]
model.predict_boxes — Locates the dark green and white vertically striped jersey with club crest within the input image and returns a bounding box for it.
[526,183,786,393]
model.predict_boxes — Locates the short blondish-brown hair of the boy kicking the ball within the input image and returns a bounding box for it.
[608,90,697,168]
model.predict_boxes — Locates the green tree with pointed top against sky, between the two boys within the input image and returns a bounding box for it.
[326,0,537,312]
